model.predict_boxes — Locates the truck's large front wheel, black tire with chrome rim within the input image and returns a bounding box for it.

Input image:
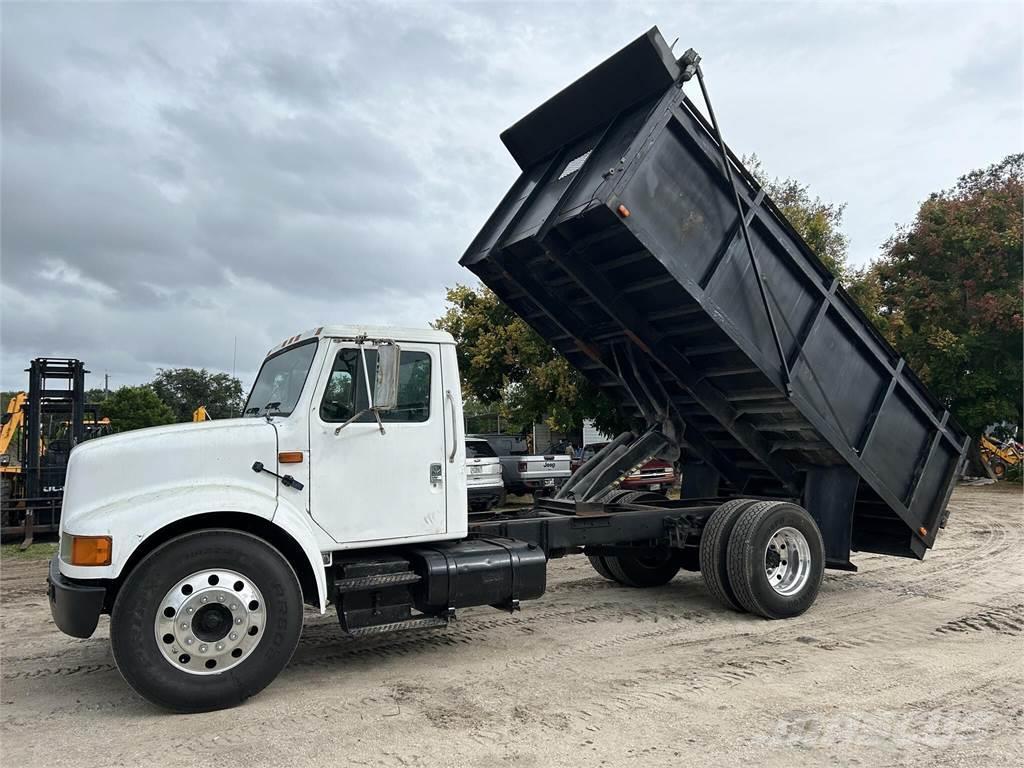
[111,530,302,712]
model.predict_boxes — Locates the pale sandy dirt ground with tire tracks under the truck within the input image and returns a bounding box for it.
[0,486,1024,768]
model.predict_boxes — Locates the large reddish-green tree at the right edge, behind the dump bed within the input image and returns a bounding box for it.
[864,154,1024,436]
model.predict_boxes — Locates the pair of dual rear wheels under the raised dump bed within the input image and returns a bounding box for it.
[700,499,824,618]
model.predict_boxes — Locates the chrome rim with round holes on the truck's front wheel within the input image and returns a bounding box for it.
[154,569,266,675]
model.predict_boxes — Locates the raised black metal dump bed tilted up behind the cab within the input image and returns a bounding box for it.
[462,29,968,567]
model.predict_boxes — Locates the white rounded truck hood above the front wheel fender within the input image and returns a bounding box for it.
[60,419,278,531]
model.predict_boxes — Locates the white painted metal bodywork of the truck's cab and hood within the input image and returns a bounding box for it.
[59,326,468,610]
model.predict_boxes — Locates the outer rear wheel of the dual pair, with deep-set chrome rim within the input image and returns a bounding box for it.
[728,502,825,618]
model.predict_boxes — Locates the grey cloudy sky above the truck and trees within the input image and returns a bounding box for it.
[0,1,1024,389]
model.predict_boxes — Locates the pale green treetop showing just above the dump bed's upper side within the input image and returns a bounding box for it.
[742,155,855,284]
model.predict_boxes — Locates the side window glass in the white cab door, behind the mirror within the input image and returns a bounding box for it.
[321,348,430,423]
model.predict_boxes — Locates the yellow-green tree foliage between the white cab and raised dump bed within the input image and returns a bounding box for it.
[433,285,624,433]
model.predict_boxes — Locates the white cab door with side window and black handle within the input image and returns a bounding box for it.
[309,340,449,546]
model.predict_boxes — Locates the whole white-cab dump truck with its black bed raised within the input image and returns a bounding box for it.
[48,29,967,712]
